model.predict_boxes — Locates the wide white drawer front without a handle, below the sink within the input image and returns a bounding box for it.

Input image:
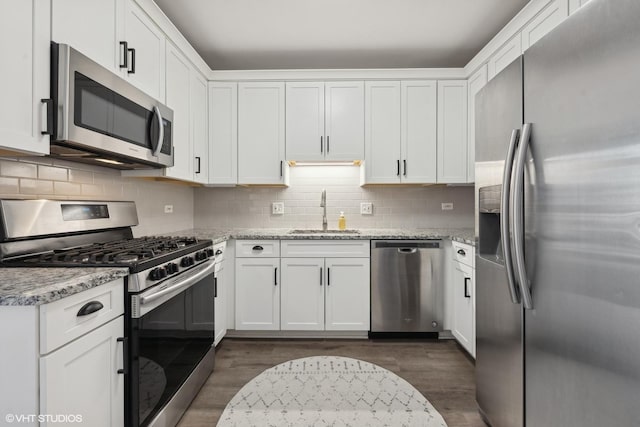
[282,240,370,258]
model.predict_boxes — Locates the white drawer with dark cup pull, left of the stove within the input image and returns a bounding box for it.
[40,279,124,354]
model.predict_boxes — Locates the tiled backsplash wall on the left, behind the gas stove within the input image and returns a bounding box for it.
[0,157,193,236]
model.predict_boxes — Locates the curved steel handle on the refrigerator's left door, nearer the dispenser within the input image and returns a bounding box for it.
[500,129,520,304]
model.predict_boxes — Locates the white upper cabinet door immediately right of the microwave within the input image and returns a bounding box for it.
[166,43,193,180]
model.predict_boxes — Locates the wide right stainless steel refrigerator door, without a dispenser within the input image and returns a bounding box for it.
[524,0,640,427]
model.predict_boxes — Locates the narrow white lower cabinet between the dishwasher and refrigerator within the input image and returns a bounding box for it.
[449,242,476,357]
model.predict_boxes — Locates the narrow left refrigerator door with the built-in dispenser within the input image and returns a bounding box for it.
[476,60,524,427]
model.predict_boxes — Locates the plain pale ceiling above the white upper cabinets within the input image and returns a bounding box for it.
[155,0,529,70]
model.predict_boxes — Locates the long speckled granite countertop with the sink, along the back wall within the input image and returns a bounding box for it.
[172,228,475,246]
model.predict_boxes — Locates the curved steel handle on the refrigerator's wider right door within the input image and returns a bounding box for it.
[511,123,533,310]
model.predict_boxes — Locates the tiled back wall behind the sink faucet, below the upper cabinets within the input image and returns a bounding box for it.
[195,166,474,228]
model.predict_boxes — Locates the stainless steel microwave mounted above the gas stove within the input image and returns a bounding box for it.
[51,43,173,169]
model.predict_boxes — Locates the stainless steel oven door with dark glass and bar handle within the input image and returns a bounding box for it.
[127,260,215,426]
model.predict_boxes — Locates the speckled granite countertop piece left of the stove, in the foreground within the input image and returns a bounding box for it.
[0,267,129,306]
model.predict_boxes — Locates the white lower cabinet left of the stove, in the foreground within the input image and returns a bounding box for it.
[0,279,125,427]
